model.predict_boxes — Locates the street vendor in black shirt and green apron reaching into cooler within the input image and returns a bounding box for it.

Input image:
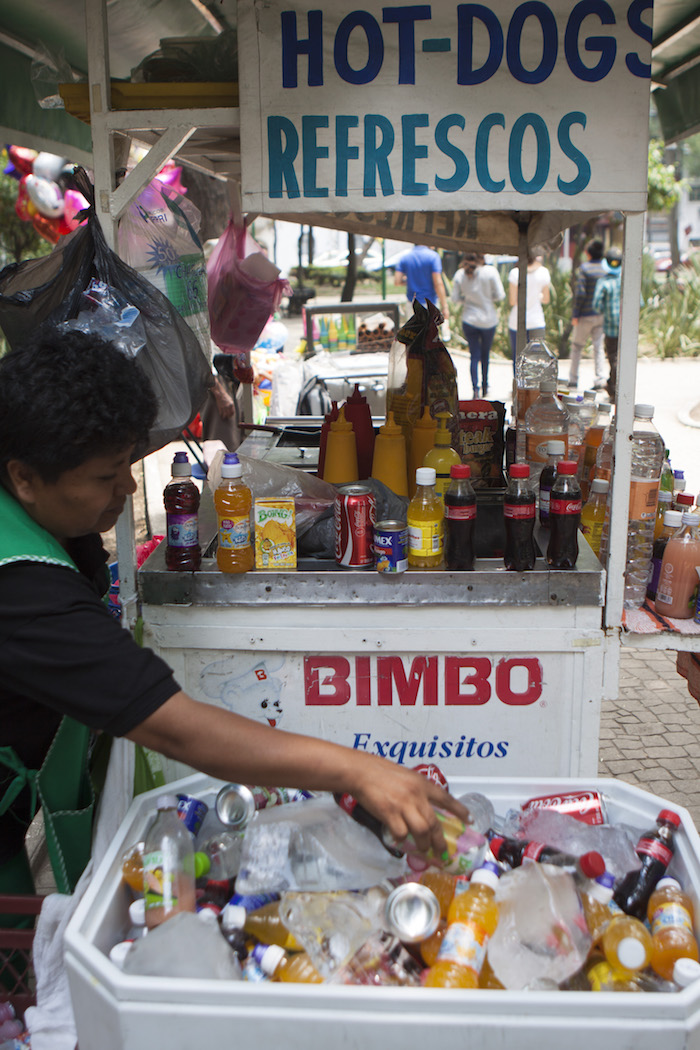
[0,329,468,893]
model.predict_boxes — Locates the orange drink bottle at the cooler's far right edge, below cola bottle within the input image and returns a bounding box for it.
[646,876,699,981]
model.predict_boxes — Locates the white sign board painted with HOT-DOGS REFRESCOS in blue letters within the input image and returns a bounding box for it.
[238,0,652,214]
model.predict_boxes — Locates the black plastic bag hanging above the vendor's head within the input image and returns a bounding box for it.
[0,168,213,456]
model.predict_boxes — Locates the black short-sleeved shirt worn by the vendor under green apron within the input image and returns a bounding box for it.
[0,536,179,860]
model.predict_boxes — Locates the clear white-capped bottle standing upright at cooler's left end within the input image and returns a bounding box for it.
[144,795,195,929]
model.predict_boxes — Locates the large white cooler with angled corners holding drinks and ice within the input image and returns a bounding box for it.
[65,775,700,1050]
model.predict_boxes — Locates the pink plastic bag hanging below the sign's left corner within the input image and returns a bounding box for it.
[207,216,292,354]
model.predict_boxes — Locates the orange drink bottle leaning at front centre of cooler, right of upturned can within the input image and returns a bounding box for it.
[423,861,499,988]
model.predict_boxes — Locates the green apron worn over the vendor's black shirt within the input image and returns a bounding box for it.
[0,485,94,894]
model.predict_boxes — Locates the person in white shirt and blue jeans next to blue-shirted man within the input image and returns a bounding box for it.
[451,252,506,398]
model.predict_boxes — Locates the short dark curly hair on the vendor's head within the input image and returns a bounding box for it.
[0,328,157,483]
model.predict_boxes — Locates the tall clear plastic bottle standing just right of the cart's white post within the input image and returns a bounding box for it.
[624,404,665,609]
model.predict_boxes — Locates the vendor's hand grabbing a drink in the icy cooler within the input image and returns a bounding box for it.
[351,752,470,857]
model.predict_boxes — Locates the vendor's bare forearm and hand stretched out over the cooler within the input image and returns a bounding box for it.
[127,692,468,855]
